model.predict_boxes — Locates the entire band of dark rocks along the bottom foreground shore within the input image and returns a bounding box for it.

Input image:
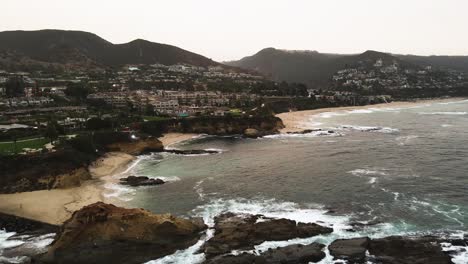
[0,202,468,264]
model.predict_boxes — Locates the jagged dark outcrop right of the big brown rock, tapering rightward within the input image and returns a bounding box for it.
[204,213,333,256]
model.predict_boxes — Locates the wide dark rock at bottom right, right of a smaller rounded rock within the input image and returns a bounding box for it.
[369,236,452,264]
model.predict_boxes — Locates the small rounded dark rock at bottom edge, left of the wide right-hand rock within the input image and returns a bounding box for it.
[328,237,370,263]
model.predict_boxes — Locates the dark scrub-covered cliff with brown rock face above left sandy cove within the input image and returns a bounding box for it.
[0,133,164,194]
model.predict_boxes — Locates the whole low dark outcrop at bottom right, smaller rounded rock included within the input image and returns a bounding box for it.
[328,237,452,264]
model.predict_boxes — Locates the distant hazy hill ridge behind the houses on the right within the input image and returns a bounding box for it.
[226,48,468,88]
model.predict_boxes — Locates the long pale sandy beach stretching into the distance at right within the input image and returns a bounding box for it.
[276,97,467,134]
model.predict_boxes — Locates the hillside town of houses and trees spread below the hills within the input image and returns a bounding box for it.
[0,55,468,154]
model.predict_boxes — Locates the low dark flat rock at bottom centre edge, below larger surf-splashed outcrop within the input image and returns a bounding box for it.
[205,243,325,264]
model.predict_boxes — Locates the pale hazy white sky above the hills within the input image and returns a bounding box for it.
[0,0,468,61]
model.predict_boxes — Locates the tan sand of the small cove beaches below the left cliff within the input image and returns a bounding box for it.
[0,133,197,225]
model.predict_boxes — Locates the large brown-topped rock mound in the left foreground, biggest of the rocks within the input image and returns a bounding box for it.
[40,203,206,264]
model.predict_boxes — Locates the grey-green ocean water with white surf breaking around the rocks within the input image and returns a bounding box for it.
[2,100,468,264]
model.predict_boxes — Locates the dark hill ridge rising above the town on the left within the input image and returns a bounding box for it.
[0,30,218,70]
